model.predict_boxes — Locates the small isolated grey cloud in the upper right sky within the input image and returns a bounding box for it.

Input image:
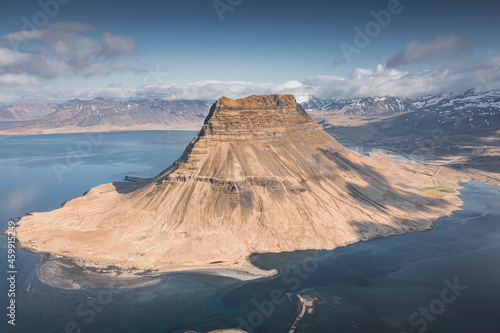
[387,32,472,67]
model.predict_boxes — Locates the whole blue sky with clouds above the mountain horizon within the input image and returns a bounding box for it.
[0,0,500,104]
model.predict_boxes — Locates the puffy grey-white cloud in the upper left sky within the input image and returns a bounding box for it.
[0,22,135,84]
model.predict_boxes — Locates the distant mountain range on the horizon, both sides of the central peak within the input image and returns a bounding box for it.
[0,90,500,134]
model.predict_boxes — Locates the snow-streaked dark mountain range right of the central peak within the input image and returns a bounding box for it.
[296,89,500,131]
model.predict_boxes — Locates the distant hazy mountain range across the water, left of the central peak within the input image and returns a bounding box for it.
[1,98,215,134]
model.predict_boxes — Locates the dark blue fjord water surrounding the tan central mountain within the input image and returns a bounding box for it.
[0,131,500,333]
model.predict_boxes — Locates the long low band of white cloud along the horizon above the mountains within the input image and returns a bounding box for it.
[0,53,500,103]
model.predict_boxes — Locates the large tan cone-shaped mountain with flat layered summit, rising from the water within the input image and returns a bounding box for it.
[16,95,460,282]
